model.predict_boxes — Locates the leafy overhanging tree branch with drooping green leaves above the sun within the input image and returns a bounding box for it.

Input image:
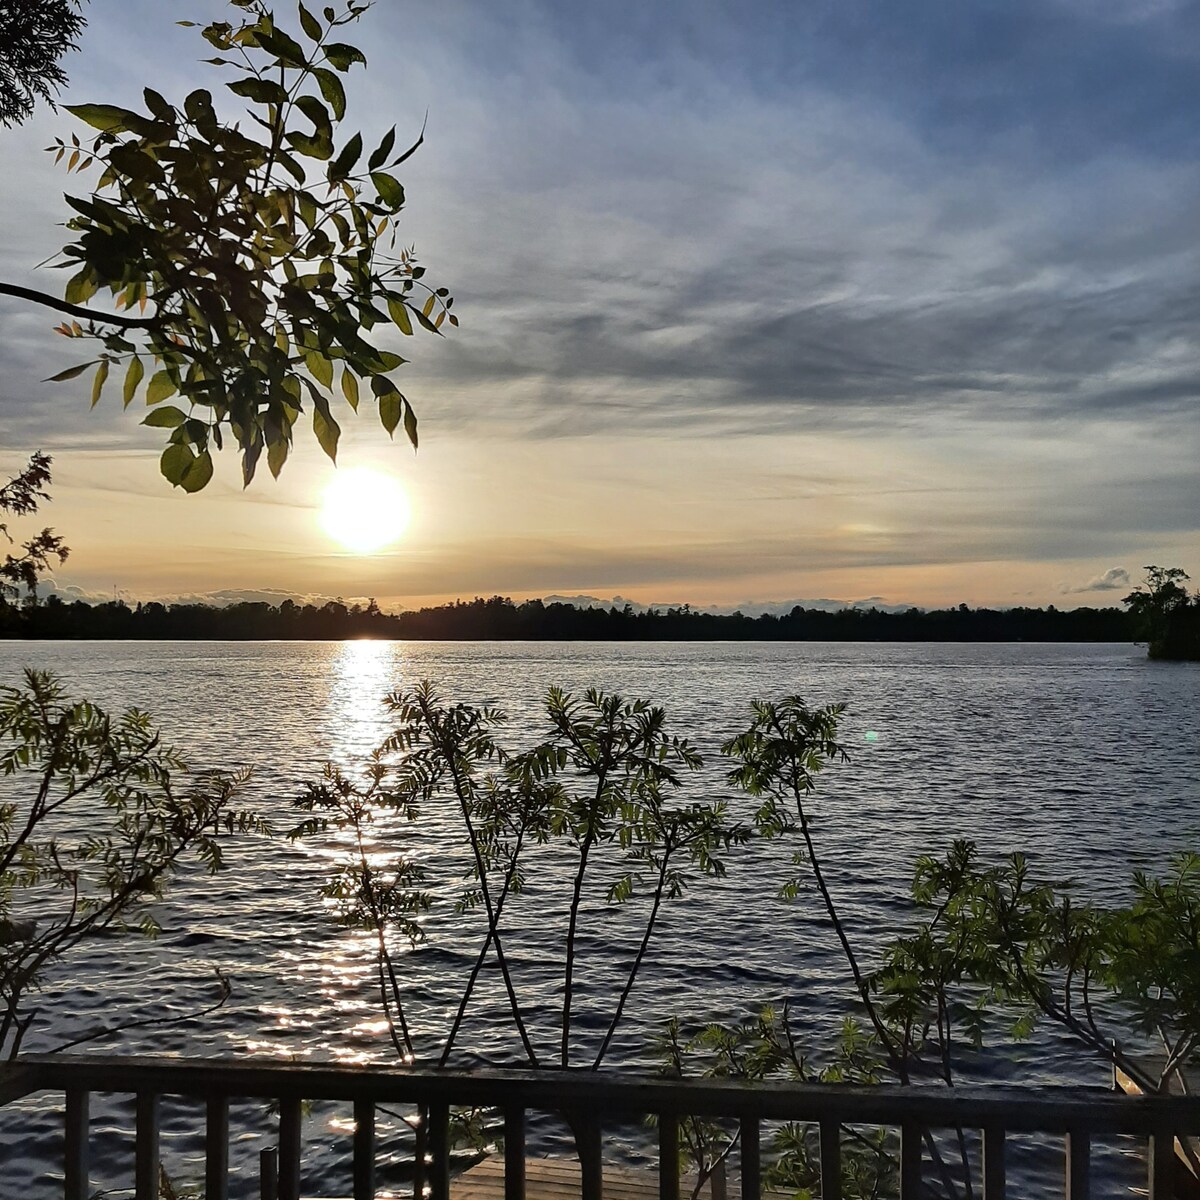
[25,0,457,492]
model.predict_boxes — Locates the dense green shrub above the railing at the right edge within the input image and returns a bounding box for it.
[902,841,1200,1090]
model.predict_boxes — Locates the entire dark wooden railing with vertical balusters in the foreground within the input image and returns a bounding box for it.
[0,1055,1200,1200]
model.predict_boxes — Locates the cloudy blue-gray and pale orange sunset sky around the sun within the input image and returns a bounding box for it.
[0,0,1200,608]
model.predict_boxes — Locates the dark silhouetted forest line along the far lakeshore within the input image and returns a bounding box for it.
[0,595,1135,642]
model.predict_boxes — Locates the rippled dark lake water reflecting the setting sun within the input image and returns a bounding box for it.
[0,642,1200,1200]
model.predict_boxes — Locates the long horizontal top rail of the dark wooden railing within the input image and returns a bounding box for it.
[0,1055,1200,1134]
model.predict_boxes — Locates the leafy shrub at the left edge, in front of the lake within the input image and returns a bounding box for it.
[0,671,262,1057]
